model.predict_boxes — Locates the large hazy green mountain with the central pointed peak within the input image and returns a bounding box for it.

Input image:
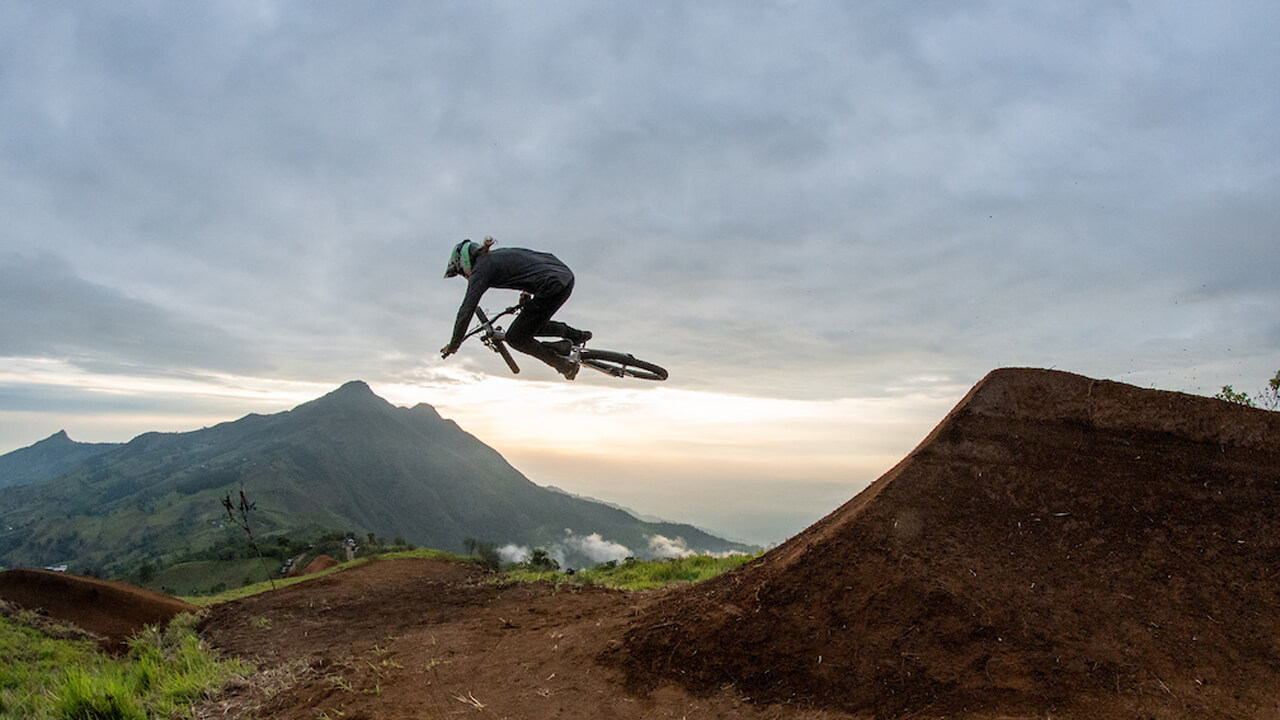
[0,382,745,573]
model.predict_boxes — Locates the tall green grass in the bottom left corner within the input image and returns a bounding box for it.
[0,614,252,720]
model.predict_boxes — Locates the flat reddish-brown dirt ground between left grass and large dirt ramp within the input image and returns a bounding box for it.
[201,560,847,720]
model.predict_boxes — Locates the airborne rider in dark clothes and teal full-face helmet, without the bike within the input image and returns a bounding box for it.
[440,237,591,380]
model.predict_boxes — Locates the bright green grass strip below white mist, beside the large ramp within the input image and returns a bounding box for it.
[504,555,760,591]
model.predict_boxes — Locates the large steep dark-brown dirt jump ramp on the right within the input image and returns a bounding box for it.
[604,369,1280,717]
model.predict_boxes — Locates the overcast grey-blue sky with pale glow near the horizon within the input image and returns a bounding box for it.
[0,0,1280,542]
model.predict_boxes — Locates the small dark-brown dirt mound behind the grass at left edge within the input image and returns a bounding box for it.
[0,568,196,650]
